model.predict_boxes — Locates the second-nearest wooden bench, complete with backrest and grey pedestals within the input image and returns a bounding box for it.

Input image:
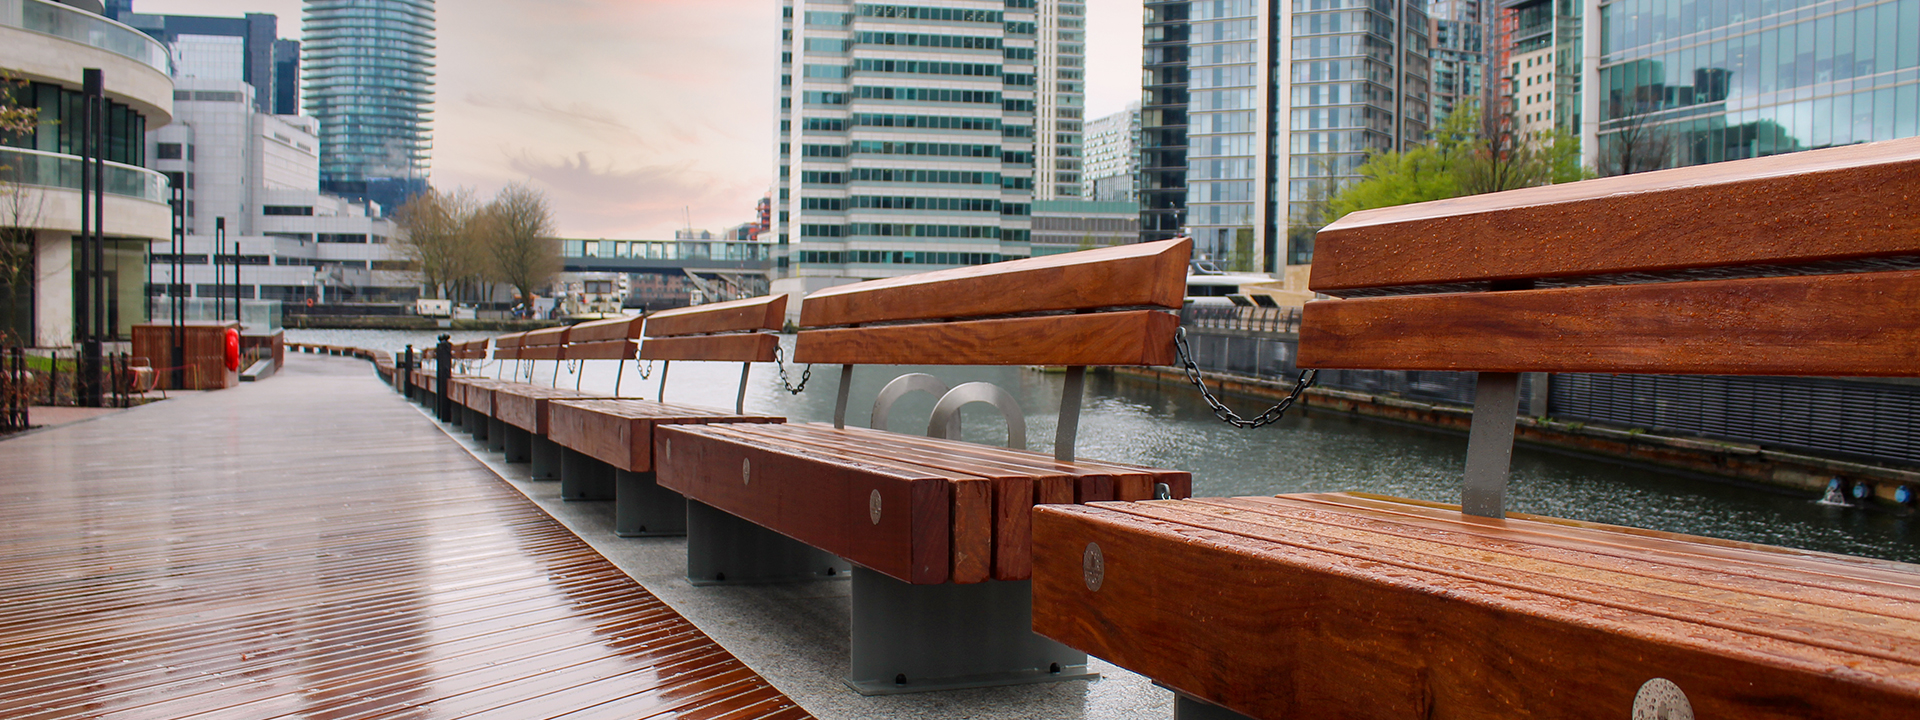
[660,240,1190,693]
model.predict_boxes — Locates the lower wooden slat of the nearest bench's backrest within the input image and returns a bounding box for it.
[1300,271,1920,376]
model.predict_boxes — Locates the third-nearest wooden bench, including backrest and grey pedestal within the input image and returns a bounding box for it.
[549,296,787,538]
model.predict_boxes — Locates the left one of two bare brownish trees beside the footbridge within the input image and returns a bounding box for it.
[394,190,486,298]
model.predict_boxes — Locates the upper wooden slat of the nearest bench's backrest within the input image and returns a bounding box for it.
[1313,138,1920,295]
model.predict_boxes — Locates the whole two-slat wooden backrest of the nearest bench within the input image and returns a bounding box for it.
[1300,138,1920,376]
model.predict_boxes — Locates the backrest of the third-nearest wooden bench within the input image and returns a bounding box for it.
[639,294,787,363]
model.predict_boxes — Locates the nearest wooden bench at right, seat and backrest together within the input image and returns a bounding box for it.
[1033,140,1920,720]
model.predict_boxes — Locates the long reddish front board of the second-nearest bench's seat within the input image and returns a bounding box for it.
[655,424,950,584]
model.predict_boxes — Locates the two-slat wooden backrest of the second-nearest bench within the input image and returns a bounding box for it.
[793,238,1192,367]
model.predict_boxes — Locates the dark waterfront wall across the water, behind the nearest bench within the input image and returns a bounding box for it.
[1181,307,1920,493]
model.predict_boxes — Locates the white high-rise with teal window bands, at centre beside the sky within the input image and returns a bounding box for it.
[772,0,1085,294]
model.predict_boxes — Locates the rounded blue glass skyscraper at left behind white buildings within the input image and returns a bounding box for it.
[303,0,434,211]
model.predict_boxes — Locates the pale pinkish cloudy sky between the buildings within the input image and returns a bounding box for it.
[132,0,1142,240]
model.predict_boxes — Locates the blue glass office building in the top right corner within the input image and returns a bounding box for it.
[1582,0,1920,175]
